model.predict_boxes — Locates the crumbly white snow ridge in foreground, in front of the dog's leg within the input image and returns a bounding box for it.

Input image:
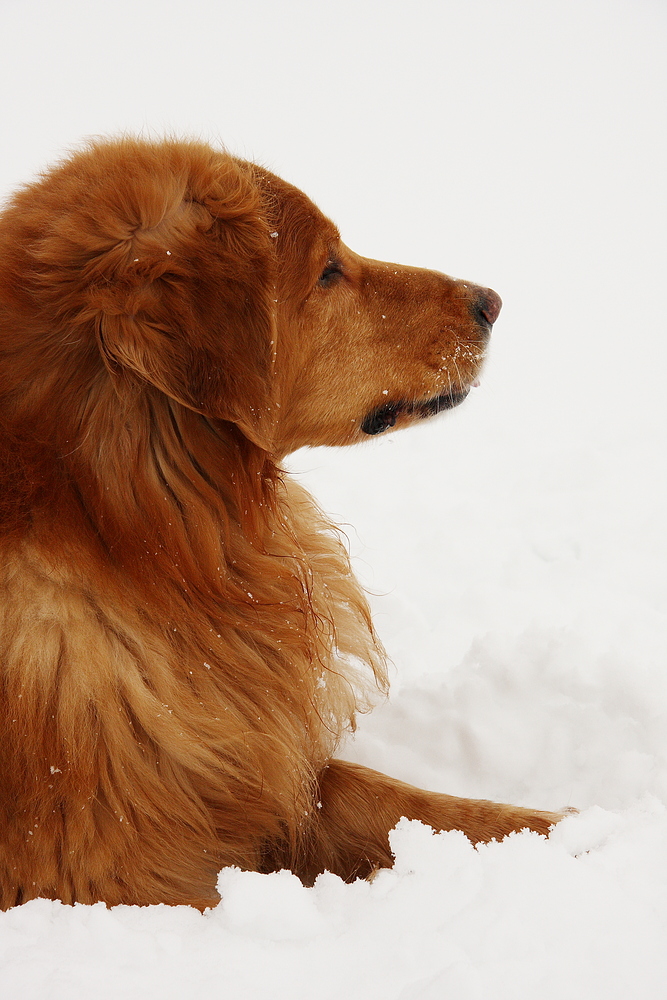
[2,801,667,1000]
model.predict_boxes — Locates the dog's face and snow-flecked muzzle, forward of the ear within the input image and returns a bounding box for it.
[257,171,501,452]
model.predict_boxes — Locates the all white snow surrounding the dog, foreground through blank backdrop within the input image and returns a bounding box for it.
[0,0,667,1000]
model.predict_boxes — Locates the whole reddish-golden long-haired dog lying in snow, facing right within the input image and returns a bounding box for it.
[0,138,560,910]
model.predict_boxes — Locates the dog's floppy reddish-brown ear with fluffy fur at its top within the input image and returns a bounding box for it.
[87,143,275,450]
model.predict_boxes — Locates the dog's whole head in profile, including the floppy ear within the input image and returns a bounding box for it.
[3,140,500,455]
